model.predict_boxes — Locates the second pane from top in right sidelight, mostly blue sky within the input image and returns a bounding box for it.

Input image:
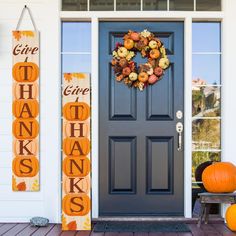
[192,55,221,85]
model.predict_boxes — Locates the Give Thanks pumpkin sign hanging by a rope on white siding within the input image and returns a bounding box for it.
[12,7,39,191]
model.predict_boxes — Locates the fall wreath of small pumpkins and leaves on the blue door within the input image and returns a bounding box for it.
[111,30,170,91]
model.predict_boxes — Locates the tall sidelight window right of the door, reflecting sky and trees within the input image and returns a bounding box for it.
[192,22,222,216]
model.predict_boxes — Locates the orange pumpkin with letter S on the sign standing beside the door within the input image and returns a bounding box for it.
[62,194,90,216]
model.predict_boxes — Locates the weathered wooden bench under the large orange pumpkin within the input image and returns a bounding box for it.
[198,192,236,227]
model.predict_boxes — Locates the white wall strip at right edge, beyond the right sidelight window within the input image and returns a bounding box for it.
[221,0,236,217]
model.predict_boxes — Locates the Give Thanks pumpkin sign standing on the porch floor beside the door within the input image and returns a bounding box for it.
[62,73,91,230]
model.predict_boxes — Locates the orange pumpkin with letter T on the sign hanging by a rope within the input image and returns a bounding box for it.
[12,61,39,82]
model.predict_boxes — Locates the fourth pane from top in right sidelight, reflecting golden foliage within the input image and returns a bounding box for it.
[192,119,220,150]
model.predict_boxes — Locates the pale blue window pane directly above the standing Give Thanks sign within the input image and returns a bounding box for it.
[62,55,91,73]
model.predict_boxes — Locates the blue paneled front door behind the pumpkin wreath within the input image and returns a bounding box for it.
[99,22,184,216]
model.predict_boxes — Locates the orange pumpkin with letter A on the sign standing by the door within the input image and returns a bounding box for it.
[63,138,90,156]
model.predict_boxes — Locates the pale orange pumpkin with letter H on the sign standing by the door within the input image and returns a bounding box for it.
[63,121,90,138]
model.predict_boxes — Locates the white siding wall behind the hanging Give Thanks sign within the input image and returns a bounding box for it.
[0,0,60,222]
